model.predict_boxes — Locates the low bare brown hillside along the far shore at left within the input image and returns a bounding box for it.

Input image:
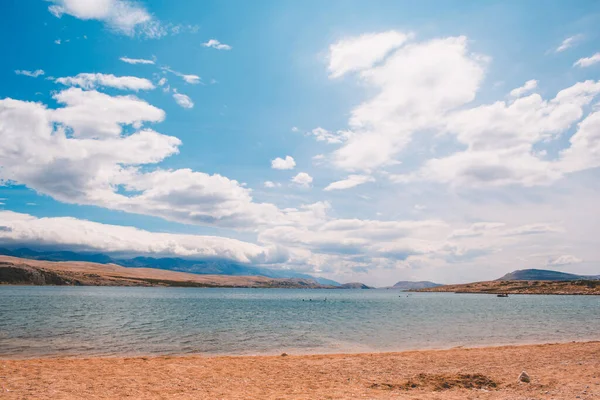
[0,256,335,289]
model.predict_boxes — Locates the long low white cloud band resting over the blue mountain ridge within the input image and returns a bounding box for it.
[0,211,285,264]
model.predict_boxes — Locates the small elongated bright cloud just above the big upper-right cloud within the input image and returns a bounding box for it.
[329,31,412,78]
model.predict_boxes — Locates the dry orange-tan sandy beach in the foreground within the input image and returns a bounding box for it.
[0,342,600,400]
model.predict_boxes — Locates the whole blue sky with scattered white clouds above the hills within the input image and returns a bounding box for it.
[0,0,600,286]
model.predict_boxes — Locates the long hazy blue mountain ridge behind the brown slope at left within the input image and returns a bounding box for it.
[0,248,341,286]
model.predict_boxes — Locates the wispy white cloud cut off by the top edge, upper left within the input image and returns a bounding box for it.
[48,0,167,38]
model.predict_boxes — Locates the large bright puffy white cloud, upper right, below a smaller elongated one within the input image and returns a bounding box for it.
[331,37,487,172]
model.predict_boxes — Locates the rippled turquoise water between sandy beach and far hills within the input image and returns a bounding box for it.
[0,286,600,357]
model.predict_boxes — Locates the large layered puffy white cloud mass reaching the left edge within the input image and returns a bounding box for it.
[0,88,285,229]
